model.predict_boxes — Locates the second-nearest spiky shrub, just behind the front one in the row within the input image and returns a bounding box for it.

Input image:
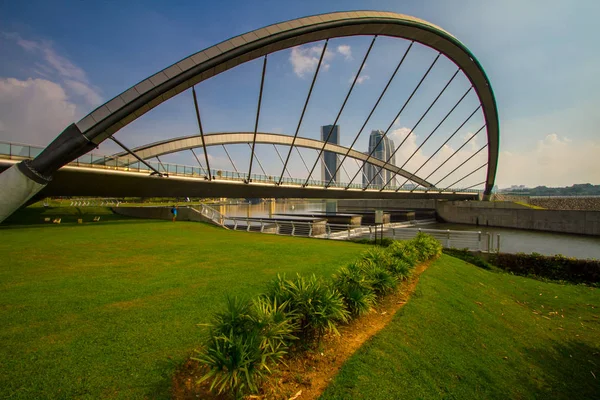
[266,274,348,344]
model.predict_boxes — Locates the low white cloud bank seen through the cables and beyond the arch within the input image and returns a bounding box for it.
[372,127,600,189]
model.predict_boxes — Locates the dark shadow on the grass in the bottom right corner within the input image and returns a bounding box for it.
[523,341,600,399]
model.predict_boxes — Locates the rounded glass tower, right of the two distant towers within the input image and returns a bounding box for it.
[363,130,396,188]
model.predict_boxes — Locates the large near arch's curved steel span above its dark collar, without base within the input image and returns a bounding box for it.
[69,11,499,193]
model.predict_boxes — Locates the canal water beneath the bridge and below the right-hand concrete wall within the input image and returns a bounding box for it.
[212,200,600,259]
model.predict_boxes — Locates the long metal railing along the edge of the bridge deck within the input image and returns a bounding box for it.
[0,141,482,193]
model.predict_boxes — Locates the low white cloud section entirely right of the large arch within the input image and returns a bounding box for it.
[496,133,600,187]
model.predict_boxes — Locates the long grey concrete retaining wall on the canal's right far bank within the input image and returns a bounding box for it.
[436,201,600,236]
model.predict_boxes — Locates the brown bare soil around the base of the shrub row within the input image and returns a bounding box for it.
[173,263,429,400]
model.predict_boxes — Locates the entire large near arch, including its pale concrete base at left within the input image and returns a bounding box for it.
[0,11,499,221]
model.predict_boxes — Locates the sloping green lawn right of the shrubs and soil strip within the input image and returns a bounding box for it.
[322,255,600,400]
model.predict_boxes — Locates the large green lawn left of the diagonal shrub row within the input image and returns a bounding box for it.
[0,220,364,399]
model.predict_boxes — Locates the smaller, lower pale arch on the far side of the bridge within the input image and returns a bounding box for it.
[107,132,434,188]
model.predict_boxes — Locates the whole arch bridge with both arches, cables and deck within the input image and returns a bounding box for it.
[0,11,499,221]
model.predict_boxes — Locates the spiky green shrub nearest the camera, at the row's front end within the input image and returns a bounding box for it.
[192,297,296,398]
